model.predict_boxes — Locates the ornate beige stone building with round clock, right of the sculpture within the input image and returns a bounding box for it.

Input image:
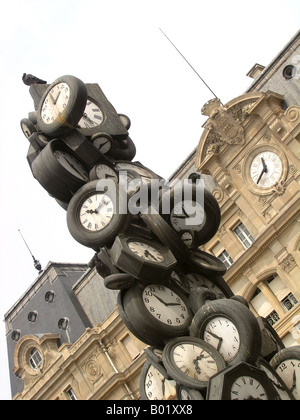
[195,33,300,346]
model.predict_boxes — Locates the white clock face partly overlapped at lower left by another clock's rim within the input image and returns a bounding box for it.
[203,316,240,362]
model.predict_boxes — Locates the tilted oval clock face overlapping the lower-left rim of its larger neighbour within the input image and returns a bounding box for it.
[173,343,218,382]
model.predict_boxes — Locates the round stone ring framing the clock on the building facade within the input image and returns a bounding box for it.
[242,143,288,195]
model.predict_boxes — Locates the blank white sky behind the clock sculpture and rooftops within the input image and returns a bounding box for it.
[0,0,300,399]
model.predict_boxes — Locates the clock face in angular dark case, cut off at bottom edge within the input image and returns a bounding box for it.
[231,376,268,400]
